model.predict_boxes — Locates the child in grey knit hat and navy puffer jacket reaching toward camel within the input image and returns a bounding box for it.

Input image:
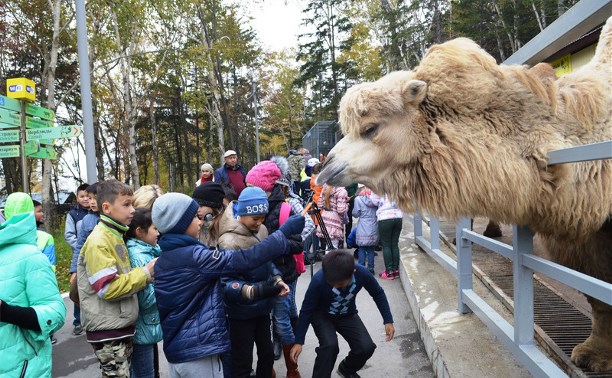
[152,193,304,377]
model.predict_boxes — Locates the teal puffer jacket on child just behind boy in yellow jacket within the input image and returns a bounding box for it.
[125,238,162,345]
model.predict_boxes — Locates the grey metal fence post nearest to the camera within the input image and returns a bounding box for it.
[512,225,534,345]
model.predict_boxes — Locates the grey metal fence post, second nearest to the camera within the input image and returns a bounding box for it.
[455,218,472,314]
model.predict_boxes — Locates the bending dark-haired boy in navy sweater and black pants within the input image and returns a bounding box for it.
[291,250,395,378]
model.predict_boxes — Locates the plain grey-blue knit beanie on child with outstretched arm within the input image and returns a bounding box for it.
[151,193,200,234]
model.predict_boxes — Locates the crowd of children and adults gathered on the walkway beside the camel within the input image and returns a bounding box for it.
[0,147,402,378]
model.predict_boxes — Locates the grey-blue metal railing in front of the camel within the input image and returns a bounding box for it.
[414,141,612,377]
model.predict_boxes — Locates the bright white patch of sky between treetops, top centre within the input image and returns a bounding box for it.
[250,0,306,51]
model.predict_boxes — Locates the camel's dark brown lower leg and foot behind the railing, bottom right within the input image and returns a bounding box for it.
[572,296,612,372]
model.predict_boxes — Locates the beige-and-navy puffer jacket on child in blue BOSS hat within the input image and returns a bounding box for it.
[219,202,280,320]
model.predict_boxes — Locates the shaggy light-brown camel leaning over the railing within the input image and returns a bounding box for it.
[317,18,612,372]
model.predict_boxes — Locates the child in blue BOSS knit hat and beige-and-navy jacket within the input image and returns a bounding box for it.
[219,187,289,377]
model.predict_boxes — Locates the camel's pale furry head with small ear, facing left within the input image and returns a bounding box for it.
[317,71,427,192]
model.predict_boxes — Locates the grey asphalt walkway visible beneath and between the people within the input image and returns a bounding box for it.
[52,252,434,378]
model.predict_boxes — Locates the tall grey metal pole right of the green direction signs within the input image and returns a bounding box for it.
[75,0,98,184]
